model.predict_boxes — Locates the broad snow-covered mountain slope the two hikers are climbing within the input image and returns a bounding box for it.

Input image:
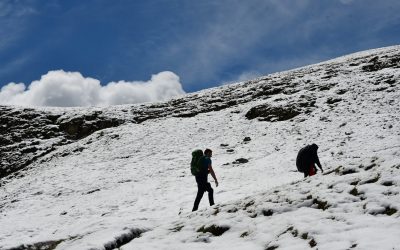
[0,46,400,250]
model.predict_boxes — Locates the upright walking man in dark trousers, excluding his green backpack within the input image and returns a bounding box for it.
[192,149,218,211]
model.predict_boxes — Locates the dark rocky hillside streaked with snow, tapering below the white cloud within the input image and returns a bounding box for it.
[0,106,123,178]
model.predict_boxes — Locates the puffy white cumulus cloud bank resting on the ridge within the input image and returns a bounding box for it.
[0,70,185,107]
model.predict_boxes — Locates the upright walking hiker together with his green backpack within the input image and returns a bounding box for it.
[190,149,218,211]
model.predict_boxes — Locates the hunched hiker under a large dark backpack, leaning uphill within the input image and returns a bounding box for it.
[296,143,324,178]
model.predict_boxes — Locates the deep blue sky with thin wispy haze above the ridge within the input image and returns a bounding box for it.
[0,0,400,105]
